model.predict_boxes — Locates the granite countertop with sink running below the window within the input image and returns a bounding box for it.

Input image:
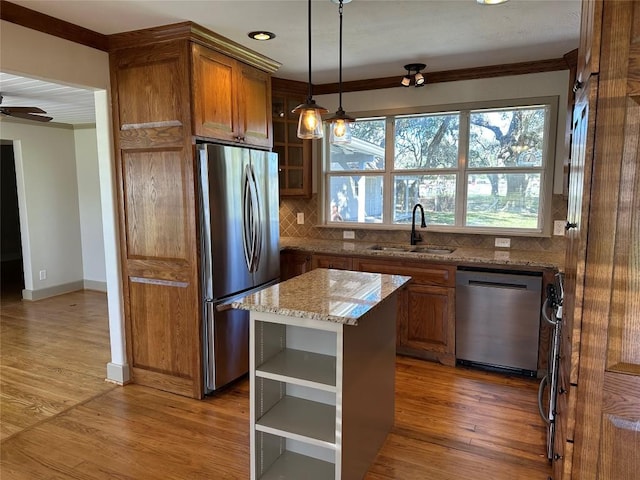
[280,237,564,271]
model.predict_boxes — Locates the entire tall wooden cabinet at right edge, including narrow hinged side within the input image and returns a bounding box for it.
[553,0,640,480]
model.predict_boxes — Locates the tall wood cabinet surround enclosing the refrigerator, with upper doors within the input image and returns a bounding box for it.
[109,22,279,398]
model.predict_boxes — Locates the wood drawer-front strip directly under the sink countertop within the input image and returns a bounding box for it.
[353,258,456,287]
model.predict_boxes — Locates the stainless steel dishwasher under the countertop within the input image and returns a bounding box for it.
[456,268,542,376]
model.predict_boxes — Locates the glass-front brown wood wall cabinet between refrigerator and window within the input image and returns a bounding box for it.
[272,91,312,198]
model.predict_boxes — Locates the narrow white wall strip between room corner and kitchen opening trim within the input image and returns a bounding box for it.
[73,127,107,291]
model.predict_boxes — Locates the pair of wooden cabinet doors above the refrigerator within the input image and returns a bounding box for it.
[191,44,273,148]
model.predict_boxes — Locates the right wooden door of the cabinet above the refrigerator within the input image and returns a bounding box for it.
[237,63,273,148]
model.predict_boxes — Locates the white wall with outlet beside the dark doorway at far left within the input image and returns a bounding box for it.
[0,120,83,299]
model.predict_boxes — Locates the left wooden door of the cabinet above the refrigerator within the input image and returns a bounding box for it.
[191,43,241,142]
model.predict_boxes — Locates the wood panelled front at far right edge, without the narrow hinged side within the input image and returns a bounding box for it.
[572,1,640,480]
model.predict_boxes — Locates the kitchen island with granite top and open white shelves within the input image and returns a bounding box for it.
[231,269,410,480]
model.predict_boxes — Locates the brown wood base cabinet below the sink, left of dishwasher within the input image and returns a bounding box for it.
[353,258,456,365]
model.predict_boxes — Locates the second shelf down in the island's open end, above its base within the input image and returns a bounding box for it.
[256,396,336,449]
